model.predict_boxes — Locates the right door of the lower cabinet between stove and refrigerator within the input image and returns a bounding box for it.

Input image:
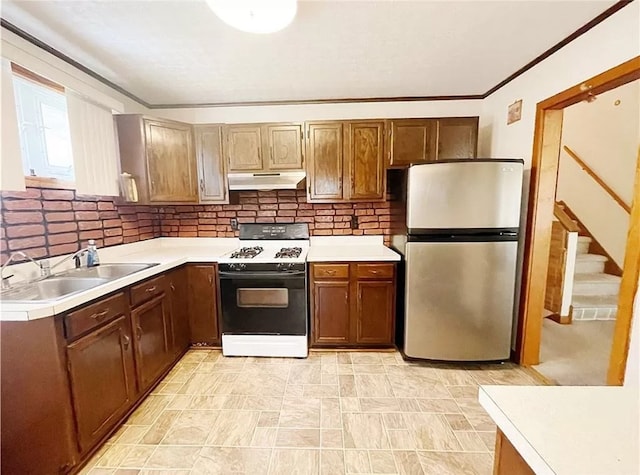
[355,280,395,345]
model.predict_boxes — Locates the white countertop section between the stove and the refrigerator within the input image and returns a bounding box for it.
[307,236,400,262]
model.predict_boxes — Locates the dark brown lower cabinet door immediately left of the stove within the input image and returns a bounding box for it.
[187,264,220,345]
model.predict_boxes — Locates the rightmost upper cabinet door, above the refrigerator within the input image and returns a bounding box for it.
[437,117,478,160]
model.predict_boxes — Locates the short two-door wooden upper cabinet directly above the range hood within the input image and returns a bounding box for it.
[224,123,303,172]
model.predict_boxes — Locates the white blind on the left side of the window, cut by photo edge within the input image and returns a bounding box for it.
[0,58,25,191]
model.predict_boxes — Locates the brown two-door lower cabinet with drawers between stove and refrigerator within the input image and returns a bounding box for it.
[310,263,396,347]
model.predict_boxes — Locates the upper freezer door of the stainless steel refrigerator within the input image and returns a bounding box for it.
[407,160,523,233]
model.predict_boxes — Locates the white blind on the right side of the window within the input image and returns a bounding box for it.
[67,91,120,196]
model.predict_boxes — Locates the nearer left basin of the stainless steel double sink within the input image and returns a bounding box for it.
[0,277,109,303]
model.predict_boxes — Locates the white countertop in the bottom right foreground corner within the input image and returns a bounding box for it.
[479,386,640,475]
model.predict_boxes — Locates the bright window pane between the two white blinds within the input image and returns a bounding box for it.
[13,70,74,181]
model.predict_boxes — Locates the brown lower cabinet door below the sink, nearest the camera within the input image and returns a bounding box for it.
[67,315,136,452]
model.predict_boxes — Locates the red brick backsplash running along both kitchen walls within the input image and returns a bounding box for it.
[0,188,404,262]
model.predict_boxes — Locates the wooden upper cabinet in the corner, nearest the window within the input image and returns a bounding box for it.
[116,115,198,203]
